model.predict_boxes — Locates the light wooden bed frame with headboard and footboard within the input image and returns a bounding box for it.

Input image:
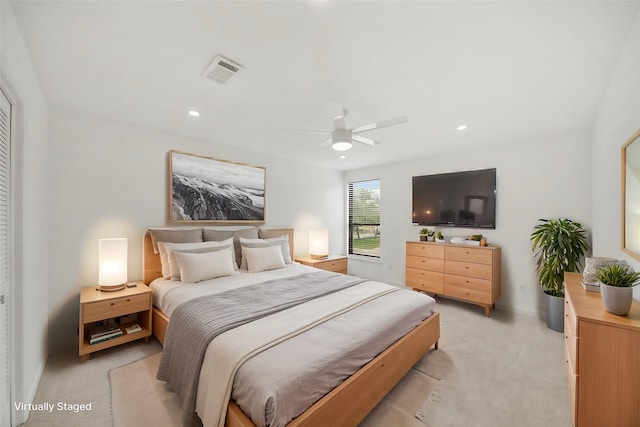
[143,228,440,427]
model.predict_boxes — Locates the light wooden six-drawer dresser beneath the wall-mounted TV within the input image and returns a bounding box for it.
[405,242,500,317]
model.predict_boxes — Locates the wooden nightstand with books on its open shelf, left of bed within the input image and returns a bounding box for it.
[78,282,153,362]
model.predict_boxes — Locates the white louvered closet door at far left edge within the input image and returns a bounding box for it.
[0,90,11,427]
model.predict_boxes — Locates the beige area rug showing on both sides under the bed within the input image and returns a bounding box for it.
[109,349,455,427]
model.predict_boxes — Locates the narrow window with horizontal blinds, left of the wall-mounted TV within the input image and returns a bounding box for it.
[349,180,380,258]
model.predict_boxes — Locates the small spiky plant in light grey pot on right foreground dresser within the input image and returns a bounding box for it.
[597,264,640,316]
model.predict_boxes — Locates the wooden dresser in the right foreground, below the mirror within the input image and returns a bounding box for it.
[564,273,640,427]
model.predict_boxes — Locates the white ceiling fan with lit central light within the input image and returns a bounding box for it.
[285,108,407,151]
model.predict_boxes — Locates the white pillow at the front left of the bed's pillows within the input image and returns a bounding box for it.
[173,246,236,283]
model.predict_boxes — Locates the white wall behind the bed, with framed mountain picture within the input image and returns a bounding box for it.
[48,108,345,352]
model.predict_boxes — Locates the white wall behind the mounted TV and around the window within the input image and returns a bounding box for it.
[345,132,591,314]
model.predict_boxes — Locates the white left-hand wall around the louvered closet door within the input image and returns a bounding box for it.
[0,1,48,423]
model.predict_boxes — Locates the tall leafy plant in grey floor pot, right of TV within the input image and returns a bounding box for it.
[531,218,589,332]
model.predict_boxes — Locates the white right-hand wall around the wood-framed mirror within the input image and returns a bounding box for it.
[592,7,640,301]
